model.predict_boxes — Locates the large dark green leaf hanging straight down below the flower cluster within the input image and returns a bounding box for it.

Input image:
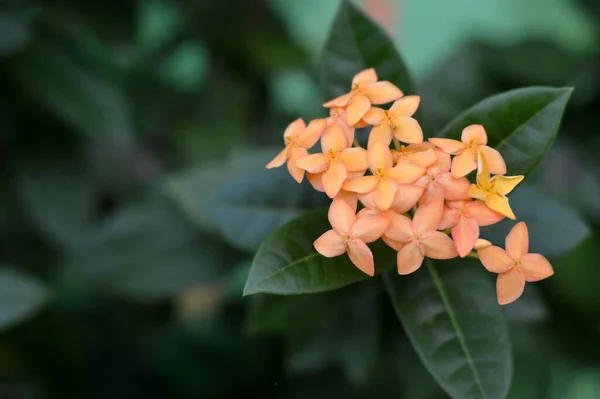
[384,259,512,399]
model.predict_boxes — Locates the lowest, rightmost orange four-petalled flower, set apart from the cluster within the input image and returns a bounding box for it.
[477,222,554,305]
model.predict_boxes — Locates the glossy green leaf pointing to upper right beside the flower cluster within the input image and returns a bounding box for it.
[438,87,573,175]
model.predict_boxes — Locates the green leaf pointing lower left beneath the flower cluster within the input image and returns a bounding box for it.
[244,210,396,295]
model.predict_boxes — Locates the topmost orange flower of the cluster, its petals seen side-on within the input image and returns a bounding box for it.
[323,68,402,126]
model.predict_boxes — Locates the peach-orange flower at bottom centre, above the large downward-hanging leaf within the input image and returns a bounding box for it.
[385,201,458,274]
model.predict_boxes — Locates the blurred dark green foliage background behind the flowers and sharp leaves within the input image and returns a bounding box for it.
[0,0,600,399]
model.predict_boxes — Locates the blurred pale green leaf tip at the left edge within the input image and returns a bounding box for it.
[0,269,49,329]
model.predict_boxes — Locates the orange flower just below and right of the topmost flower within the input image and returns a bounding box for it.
[363,96,423,148]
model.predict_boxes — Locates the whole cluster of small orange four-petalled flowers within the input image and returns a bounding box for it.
[267,68,553,304]
